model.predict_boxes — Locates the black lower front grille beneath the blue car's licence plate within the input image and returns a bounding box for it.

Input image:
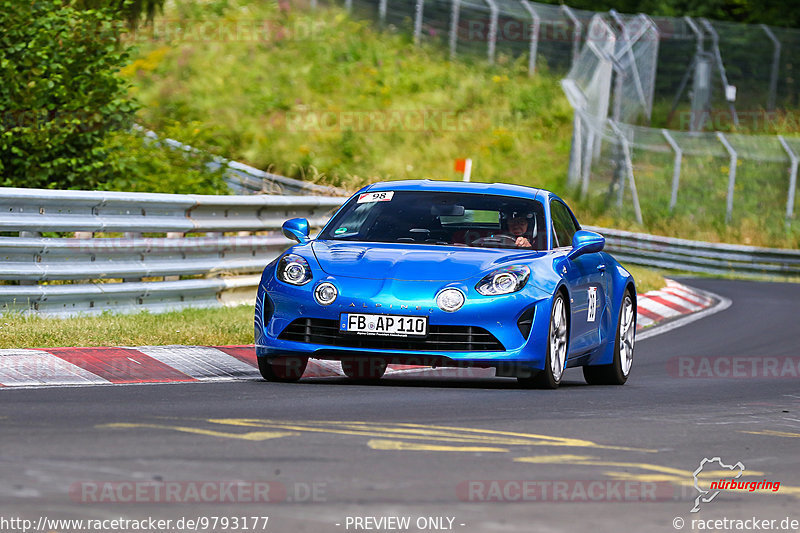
[278,318,505,352]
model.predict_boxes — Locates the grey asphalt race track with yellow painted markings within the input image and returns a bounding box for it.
[0,279,800,532]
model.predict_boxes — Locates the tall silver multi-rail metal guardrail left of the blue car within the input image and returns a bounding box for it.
[0,186,344,315]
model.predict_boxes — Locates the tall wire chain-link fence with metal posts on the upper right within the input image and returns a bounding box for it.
[316,0,800,235]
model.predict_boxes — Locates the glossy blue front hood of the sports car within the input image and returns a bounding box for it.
[311,241,544,281]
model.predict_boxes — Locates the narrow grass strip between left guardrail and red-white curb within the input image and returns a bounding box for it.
[0,305,253,348]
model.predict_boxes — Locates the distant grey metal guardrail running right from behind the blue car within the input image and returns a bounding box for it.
[584,226,800,277]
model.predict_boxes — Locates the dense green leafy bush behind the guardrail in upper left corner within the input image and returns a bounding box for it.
[0,0,135,189]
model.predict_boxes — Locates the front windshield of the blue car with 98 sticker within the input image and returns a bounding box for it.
[319,191,547,250]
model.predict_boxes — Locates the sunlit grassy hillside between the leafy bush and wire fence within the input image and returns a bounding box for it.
[123,0,572,191]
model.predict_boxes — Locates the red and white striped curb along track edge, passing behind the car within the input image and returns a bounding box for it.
[0,280,730,389]
